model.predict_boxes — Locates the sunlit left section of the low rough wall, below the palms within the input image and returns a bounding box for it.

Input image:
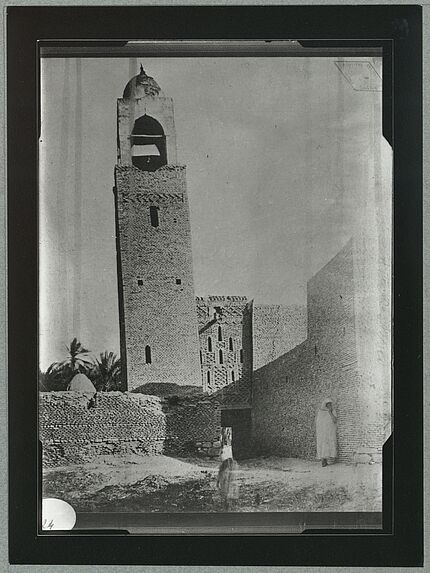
[39,392,166,465]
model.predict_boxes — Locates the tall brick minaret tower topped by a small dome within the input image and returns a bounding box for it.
[114,66,201,390]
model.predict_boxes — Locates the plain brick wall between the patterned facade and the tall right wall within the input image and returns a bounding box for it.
[252,304,307,370]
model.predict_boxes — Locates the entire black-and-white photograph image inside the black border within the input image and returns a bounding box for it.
[39,47,392,530]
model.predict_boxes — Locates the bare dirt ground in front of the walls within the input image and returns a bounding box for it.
[43,455,382,513]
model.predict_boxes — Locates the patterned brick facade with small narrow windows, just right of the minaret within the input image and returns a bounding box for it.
[196,296,252,406]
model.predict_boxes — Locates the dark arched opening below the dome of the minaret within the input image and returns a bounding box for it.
[131,114,167,171]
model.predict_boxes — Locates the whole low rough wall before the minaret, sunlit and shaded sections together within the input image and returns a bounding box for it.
[39,391,220,466]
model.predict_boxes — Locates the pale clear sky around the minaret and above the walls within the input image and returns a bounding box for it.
[39,53,385,369]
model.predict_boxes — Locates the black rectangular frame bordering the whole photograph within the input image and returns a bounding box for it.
[7,5,423,566]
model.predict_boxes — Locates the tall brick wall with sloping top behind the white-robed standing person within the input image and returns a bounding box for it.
[253,242,382,461]
